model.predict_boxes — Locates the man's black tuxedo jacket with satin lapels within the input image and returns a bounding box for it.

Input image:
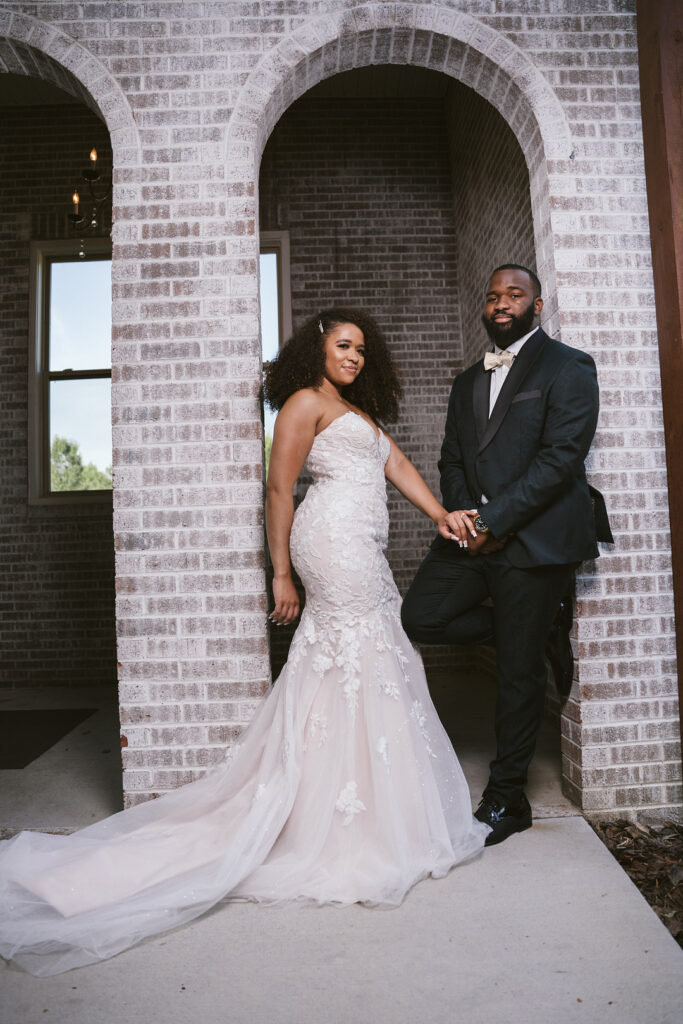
[435,330,599,568]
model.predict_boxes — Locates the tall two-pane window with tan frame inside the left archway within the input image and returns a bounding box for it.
[29,239,112,505]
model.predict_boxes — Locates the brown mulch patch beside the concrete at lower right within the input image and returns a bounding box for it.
[593,821,683,947]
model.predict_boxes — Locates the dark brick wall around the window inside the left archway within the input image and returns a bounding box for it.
[0,106,116,688]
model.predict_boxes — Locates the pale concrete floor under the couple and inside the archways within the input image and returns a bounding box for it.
[0,681,683,1024]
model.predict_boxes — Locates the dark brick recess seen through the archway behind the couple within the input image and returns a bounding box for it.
[258,63,571,813]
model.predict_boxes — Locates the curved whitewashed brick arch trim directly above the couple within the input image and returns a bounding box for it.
[226,4,574,331]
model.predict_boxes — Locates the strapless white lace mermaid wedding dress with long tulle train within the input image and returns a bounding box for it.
[0,412,488,975]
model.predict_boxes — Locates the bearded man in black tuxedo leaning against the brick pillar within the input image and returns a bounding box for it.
[402,263,598,846]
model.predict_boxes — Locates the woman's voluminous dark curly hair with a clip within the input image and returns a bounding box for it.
[263,307,402,422]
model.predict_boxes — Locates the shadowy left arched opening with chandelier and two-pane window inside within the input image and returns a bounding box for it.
[0,59,121,830]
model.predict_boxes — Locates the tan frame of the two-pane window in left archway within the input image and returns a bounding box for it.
[29,239,114,509]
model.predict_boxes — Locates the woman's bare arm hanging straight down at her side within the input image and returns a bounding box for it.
[265,391,319,626]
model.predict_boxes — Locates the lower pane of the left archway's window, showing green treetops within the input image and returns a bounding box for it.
[50,379,112,490]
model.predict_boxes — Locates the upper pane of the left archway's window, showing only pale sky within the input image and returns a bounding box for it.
[49,259,112,371]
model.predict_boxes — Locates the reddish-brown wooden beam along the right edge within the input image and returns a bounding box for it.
[637,0,683,749]
